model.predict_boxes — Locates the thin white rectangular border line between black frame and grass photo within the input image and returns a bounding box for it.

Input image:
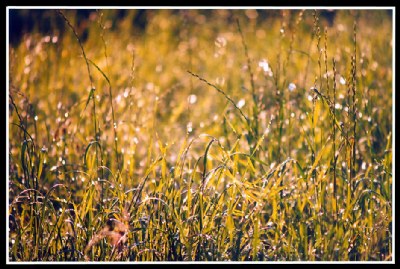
[5,6,396,265]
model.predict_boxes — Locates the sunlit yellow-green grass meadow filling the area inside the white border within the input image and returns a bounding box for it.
[7,9,394,262]
